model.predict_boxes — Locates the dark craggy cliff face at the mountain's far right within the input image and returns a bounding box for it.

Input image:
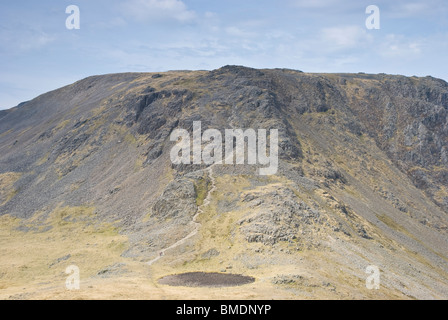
[351,76,448,211]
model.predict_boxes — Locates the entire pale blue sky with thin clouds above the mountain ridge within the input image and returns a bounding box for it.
[0,0,448,109]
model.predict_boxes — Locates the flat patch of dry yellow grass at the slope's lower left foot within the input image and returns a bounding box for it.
[0,208,127,299]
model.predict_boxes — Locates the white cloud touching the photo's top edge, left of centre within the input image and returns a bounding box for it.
[123,0,196,22]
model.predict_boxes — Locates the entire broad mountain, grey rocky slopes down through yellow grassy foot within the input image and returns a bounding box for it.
[0,66,448,299]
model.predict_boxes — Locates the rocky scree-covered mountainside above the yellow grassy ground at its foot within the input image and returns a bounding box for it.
[0,66,448,297]
